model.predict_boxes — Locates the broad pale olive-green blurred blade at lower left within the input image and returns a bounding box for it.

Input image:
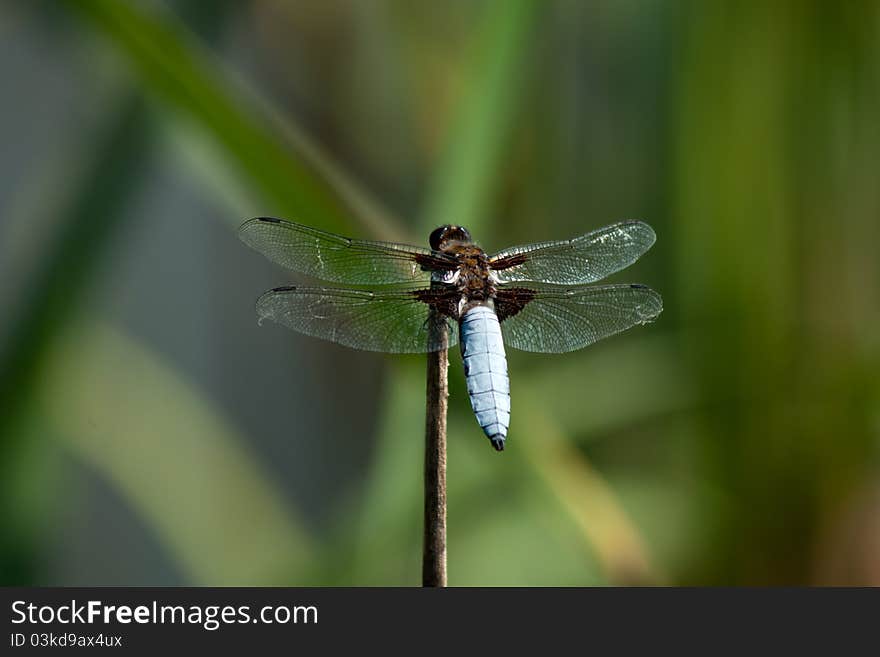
[38,323,314,586]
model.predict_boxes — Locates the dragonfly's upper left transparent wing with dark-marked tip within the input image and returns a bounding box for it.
[238,217,455,285]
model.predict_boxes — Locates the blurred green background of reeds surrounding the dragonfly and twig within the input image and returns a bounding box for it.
[0,0,880,585]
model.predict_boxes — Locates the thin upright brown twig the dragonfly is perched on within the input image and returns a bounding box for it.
[422,314,449,586]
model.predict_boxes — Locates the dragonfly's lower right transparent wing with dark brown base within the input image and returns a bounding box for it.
[495,285,663,353]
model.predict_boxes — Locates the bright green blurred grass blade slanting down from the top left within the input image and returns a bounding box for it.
[66,0,403,238]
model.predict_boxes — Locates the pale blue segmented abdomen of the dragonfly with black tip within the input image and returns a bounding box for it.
[460,306,510,451]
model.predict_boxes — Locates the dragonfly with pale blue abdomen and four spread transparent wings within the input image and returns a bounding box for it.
[239,217,663,451]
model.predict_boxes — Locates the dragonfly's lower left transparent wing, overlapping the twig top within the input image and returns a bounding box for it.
[257,287,458,353]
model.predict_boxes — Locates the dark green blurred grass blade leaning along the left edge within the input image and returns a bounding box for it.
[0,94,152,564]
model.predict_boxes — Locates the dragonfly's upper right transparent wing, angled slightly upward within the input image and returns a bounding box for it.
[489,221,657,285]
